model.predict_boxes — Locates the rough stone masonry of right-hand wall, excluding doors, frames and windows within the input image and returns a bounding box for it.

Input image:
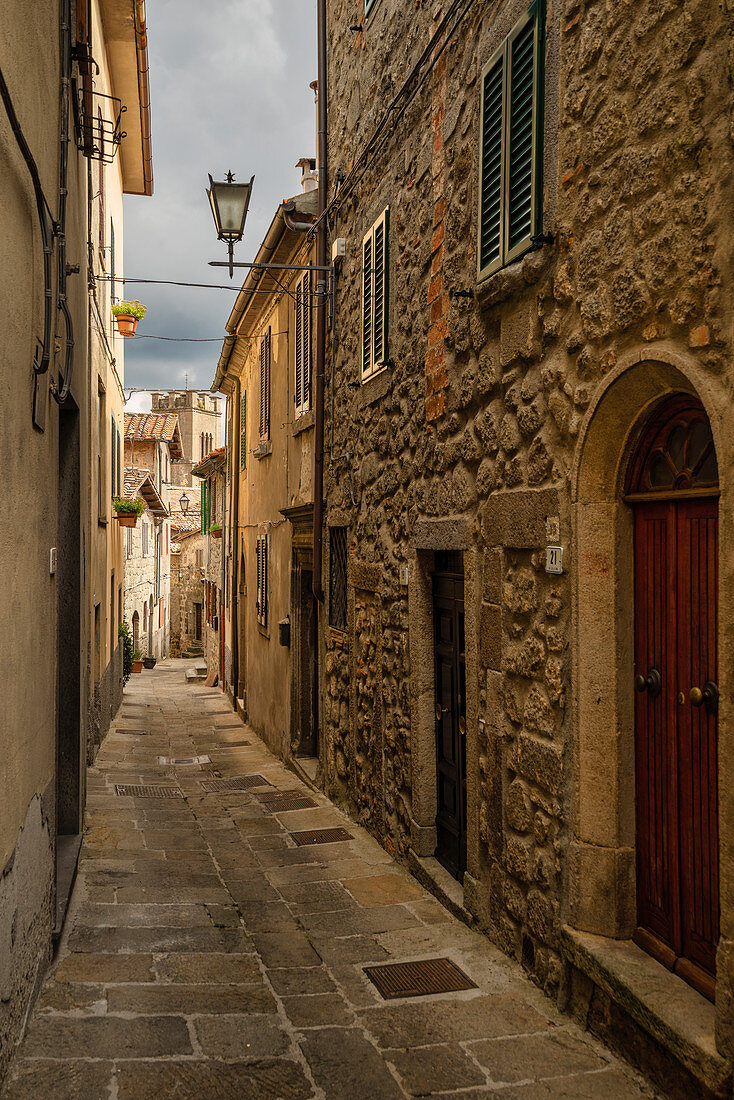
[324,0,733,991]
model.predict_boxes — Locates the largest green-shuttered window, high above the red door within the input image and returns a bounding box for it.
[476,0,543,278]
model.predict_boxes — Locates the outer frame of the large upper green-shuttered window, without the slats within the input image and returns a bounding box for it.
[476,0,545,283]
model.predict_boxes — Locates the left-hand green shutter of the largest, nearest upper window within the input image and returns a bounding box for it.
[479,51,504,272]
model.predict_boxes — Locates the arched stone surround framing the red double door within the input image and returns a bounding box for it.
[567,347,734,1053]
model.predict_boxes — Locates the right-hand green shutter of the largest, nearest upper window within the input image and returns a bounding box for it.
[507,18,537,253]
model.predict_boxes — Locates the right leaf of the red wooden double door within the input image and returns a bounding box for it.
[677,499,719,975]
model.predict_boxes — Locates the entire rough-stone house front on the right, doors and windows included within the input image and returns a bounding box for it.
[312,0,734,1096]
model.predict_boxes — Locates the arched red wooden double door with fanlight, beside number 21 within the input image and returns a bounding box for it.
[624,395,719,1000]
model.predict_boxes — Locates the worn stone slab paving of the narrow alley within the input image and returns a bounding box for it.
[2,660,655,1100]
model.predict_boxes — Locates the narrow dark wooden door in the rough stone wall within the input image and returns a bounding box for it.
[434,553,467,880]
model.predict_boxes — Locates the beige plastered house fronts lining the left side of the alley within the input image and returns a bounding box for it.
[0,0,153,1080]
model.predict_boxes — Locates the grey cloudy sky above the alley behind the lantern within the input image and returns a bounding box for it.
[124,0,316,410]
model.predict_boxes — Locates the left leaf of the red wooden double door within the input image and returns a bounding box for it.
[635,503,680,953]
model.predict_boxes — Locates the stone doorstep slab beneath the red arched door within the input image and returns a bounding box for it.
[561,925,731,1096]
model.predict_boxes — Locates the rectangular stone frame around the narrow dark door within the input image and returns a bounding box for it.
[408,516,481,878]
